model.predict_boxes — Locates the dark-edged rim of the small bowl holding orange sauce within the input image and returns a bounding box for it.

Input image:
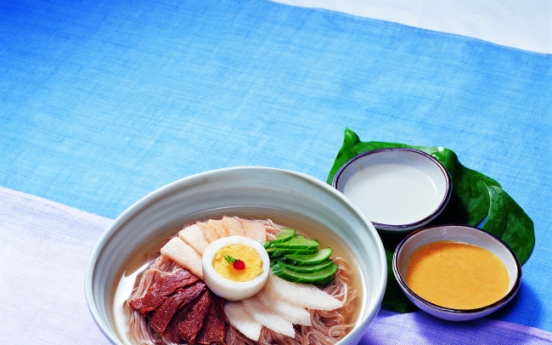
[392,224,522,315]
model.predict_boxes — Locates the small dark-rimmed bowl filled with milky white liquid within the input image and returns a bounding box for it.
[333,148,452,233]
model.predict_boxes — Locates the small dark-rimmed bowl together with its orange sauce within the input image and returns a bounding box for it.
[393,225,521,321]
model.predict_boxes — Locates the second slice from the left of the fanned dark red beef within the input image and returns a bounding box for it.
[150,282,207,335]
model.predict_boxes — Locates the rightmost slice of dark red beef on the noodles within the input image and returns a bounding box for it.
[197,296,226,345]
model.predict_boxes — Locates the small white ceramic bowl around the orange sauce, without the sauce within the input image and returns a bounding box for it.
[393,225,521,321]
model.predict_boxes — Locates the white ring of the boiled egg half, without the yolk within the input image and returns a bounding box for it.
[201,236,270,301]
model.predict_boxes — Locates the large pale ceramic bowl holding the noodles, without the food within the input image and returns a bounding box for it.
[85,167,387,345]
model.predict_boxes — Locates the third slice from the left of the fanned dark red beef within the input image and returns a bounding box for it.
[166,290,213,344]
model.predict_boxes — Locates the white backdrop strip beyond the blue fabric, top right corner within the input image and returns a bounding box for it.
[274,0,552,54]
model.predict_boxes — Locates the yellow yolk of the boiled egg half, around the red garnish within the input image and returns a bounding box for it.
[213,243,263,282]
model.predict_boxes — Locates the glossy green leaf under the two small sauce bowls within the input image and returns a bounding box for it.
[326,128,535,313]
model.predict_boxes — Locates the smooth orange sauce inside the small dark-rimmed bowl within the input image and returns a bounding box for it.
[405,241,510,309]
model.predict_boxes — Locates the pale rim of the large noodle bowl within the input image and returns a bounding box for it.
[84,166,389,344]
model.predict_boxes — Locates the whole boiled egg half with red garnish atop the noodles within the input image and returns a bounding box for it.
[201,236,270,301]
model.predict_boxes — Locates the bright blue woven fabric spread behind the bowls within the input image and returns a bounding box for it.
[0,0,552,331]
